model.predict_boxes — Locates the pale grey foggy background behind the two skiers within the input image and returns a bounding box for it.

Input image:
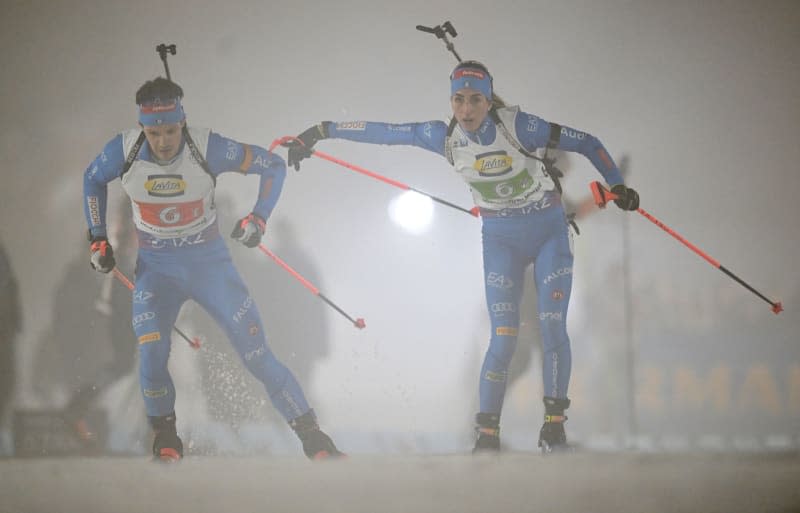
[0,0,800,452]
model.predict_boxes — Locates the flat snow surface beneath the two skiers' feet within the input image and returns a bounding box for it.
[0,453,800,513]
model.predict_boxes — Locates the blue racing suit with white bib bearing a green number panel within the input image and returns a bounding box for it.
[327,108,622,415]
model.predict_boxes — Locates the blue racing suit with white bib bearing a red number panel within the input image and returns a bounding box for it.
[84,129,309,421]
